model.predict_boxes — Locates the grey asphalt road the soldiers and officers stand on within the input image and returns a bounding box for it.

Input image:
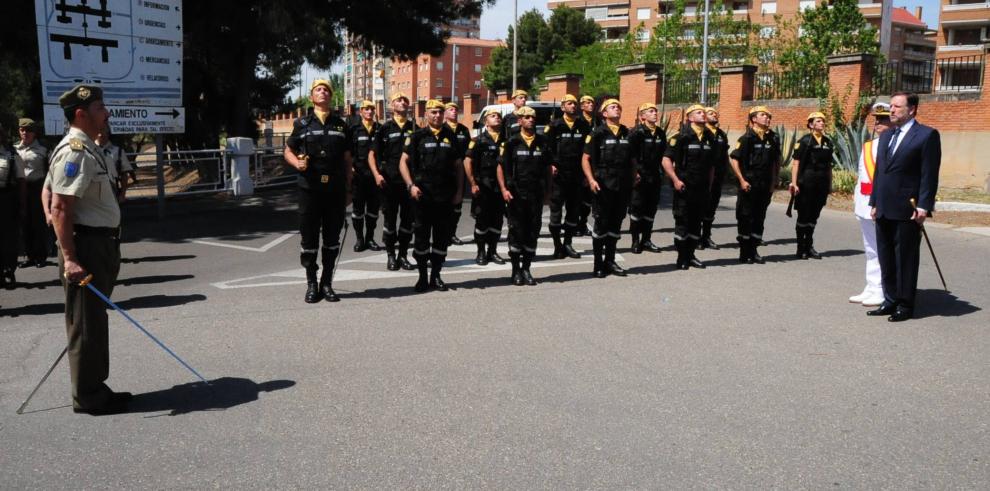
[0,188,990,489]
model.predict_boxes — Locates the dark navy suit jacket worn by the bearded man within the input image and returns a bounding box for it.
[870,120,942,220]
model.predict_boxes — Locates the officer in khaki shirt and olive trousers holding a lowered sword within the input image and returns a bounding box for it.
[50,85,131,415]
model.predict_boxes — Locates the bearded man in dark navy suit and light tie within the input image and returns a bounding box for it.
[867,92,942,322]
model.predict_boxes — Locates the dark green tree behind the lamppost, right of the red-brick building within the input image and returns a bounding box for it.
[482,7,601,90]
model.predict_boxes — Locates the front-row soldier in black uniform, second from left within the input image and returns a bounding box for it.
[399,100,464,292]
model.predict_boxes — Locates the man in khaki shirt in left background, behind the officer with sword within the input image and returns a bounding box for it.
[14,118,50,268]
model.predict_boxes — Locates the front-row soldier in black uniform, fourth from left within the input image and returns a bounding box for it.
[581,99,639,278]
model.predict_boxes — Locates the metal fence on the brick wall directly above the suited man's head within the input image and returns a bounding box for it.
[872,55,986,94]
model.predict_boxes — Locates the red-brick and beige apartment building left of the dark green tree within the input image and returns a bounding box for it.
[388,37,504,107]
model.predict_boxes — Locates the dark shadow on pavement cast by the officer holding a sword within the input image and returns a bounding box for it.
[127,377,296,416]
